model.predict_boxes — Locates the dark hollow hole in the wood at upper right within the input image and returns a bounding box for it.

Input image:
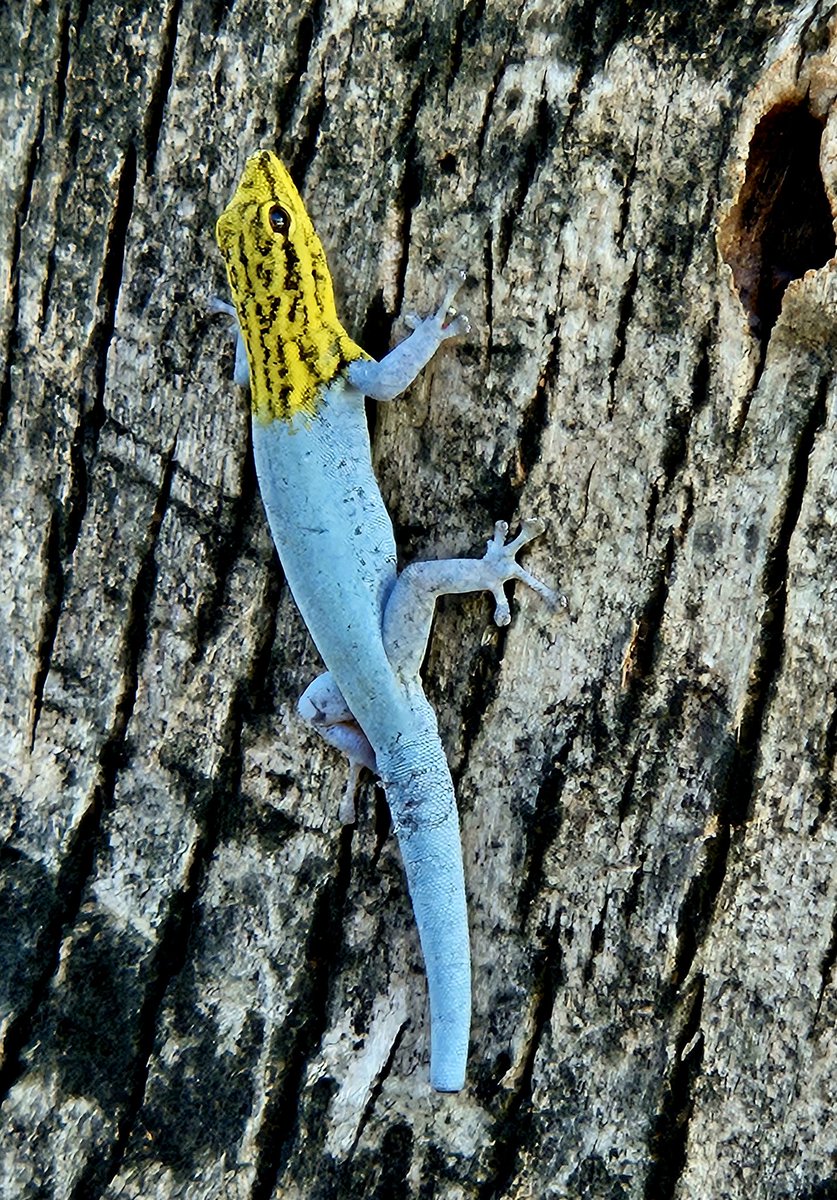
[719,101,835,346]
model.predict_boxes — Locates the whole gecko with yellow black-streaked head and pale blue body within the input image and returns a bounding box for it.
[216,150,556,1092]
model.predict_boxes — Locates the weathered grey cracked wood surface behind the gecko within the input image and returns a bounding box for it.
[0,0,837,1200]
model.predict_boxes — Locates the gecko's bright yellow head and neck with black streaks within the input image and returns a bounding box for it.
[215,150,365,422]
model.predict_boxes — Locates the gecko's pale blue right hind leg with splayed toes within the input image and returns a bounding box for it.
[384,520,554,679]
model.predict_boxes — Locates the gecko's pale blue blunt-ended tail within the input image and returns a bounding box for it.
[381,738,471,1092]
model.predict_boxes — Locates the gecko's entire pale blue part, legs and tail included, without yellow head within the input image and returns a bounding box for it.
[220,281,553,1091]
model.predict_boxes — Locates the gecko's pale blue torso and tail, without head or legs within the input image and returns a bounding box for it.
[253,382,471,1091]
